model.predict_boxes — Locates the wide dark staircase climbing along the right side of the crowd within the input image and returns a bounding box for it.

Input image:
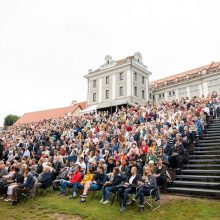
[167,119,220,198]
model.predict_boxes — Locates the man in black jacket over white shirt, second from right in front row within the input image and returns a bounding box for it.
[118,166,141,212]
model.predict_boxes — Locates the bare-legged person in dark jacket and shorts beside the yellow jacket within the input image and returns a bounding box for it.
[81,166,107,202]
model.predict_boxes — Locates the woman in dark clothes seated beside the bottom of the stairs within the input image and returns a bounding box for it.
[154,158,167,192]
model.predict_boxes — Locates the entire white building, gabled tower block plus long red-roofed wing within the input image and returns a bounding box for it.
[85,52,220,109]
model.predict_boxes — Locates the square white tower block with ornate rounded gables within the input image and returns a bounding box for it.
[85,52,151,109]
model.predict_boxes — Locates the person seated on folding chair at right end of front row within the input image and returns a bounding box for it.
[133,166,159,212]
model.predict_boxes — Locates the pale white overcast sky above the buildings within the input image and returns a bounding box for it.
[0,0,220,124]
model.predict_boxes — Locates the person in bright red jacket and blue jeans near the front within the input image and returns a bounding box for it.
[60,166,82,195]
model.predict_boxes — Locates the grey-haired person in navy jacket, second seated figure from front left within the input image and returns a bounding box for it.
[33,166,52,197]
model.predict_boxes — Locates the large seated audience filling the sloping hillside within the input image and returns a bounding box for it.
[0,96,220,212]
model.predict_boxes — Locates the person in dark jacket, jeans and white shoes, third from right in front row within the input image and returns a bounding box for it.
[100,167,123,204]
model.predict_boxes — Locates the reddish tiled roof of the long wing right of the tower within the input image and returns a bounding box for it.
[150,61,220,86]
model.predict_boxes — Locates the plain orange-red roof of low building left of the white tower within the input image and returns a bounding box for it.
[15,102,87,125]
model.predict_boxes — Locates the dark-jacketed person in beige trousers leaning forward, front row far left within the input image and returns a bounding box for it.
[11,167,35,205]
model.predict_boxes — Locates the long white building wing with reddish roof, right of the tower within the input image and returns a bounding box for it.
[149,62,220,103]
